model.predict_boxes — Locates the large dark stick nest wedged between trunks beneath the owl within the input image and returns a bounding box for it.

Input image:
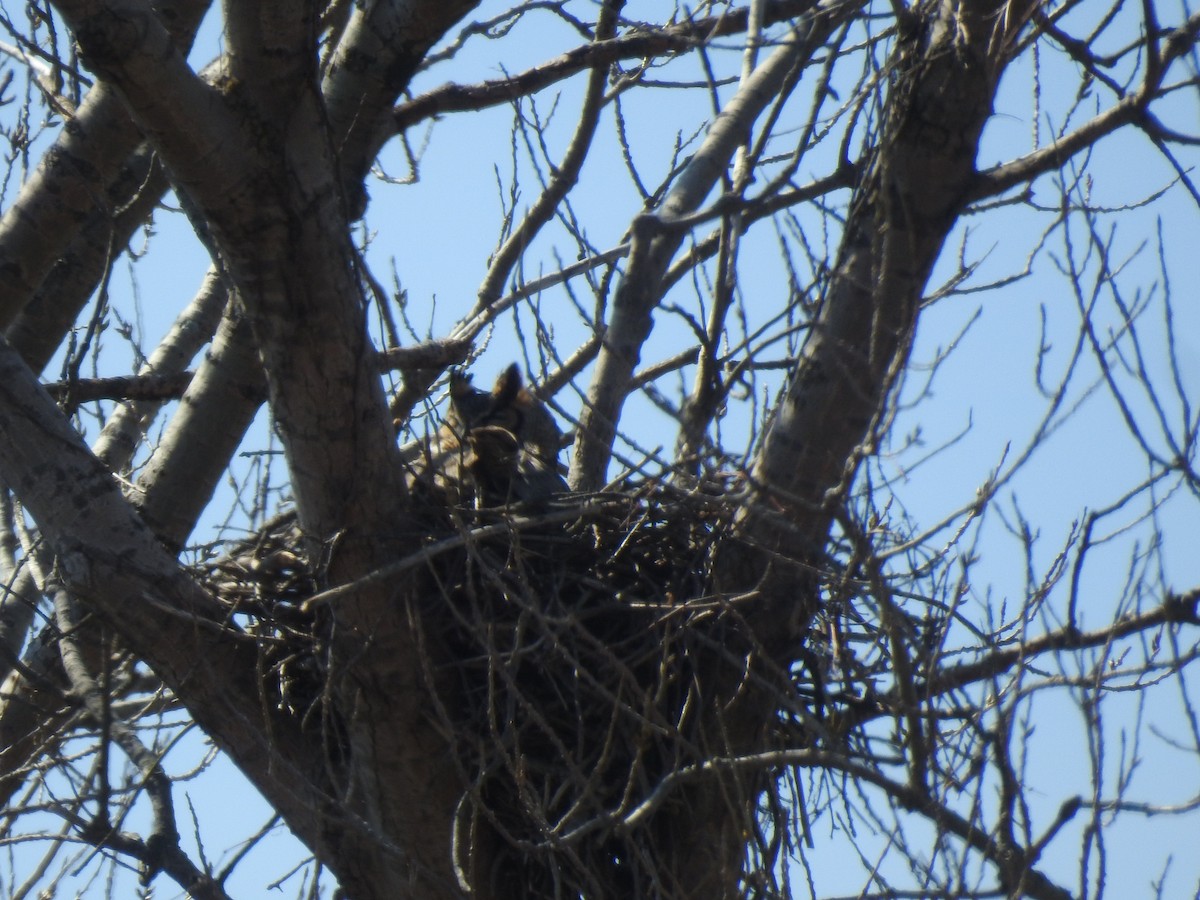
[193,482,748,896]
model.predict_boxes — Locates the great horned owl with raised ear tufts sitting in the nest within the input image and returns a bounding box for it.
[416,364,566,506]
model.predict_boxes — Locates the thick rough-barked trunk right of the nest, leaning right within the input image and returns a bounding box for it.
[667,4,1051,896]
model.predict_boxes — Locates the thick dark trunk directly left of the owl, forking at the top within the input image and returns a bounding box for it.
[42,2,489,896]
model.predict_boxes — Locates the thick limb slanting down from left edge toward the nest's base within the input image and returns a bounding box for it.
[0,343,331,868]
